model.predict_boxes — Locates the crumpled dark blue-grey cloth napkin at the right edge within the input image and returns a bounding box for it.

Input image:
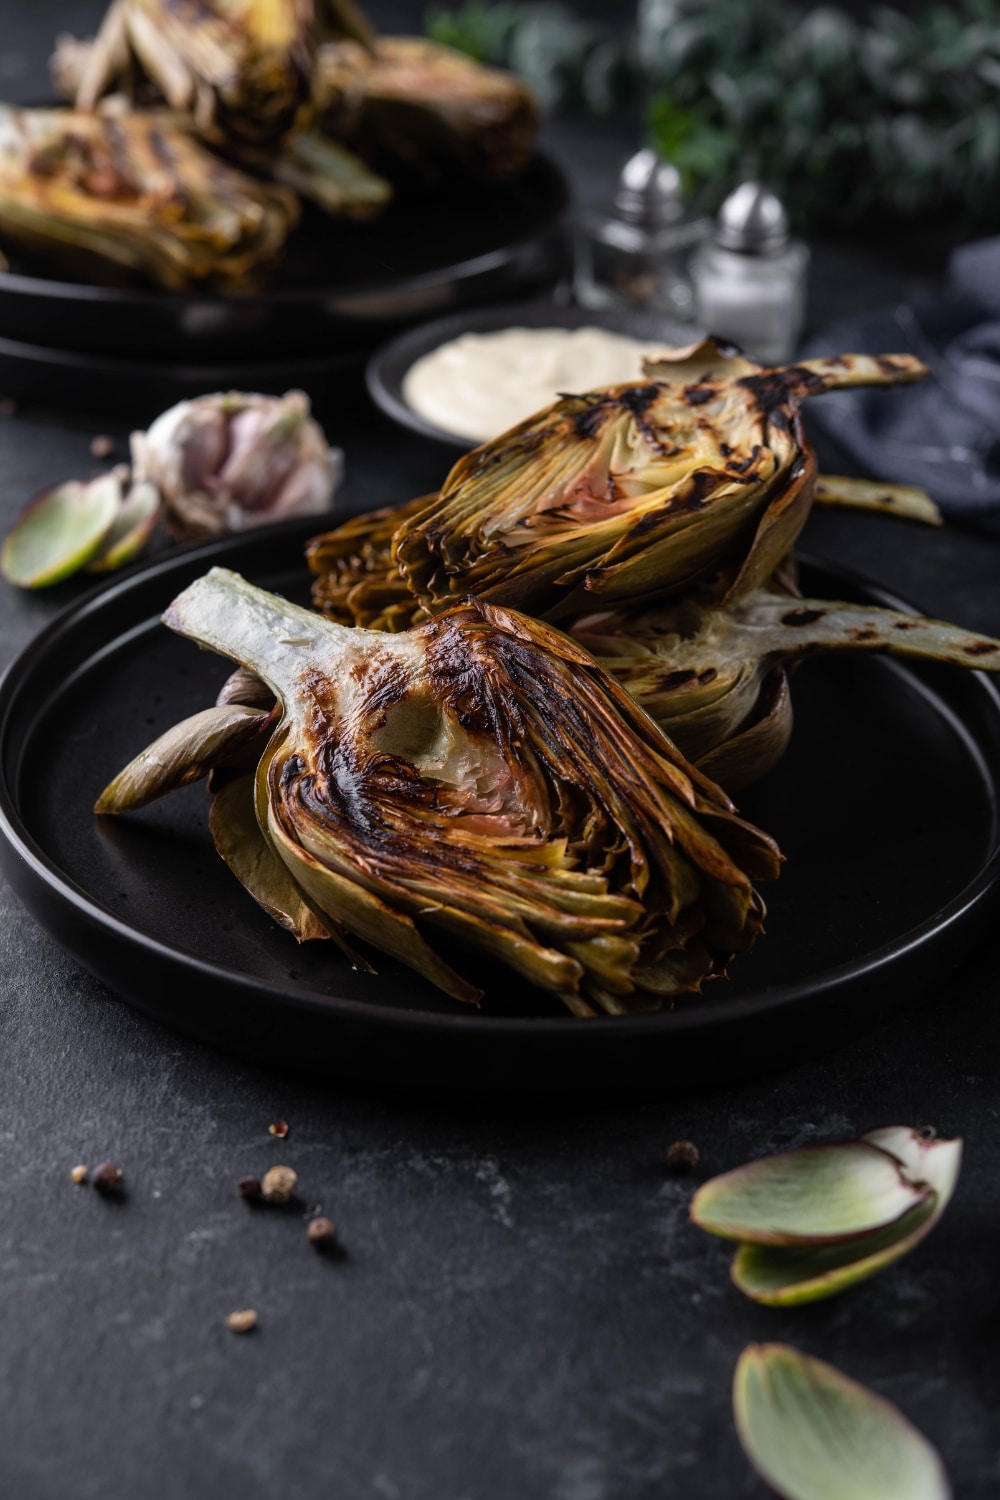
[804,239,1000,536]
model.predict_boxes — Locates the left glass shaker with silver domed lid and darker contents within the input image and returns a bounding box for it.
[574,147,711,320]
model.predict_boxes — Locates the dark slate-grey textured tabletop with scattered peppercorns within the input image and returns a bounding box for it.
[0,0,1000,1500]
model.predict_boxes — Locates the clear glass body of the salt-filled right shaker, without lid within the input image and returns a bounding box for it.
[691,240,810,365]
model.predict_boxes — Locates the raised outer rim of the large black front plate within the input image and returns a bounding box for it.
[0,518,1000,1038]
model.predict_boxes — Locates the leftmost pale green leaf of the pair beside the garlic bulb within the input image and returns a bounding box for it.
[0,473,121,588]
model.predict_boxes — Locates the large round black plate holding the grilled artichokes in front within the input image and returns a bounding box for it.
[0,522,1000,1089]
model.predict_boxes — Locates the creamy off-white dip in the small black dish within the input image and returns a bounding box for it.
[403,329,677,443]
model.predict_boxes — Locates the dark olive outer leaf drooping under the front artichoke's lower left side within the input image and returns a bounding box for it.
[208,773,330,942]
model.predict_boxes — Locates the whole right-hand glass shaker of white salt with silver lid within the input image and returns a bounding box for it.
[691,182,810,365]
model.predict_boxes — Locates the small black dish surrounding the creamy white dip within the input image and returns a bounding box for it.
[366,300,693,453]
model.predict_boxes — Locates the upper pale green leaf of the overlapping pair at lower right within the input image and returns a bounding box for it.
[691,1140,933,1245]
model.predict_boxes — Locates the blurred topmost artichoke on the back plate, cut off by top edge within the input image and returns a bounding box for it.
[76,0,321,146]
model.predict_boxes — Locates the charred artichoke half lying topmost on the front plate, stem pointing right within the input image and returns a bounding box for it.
[393,344,927,618]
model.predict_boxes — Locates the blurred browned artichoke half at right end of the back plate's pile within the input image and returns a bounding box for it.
[319,36,538,183]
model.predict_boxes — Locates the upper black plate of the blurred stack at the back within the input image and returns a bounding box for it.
[0,156,568,365]
